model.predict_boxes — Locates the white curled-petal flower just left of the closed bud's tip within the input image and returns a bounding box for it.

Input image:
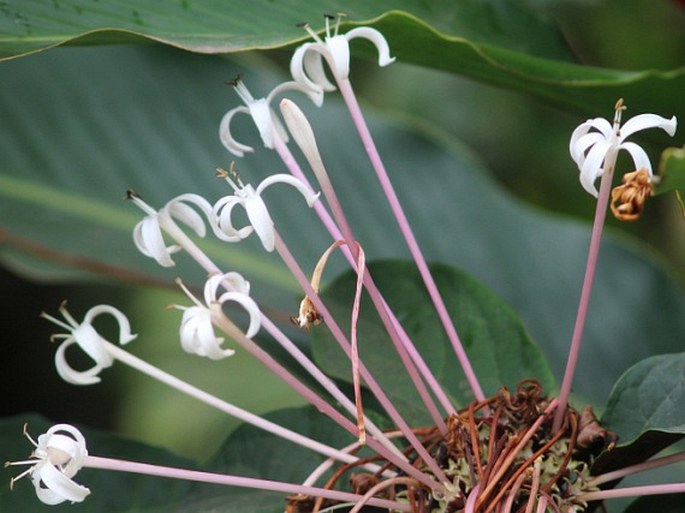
[219,77,323,157]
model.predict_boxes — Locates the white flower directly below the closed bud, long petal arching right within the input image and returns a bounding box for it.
[212,170,319,251]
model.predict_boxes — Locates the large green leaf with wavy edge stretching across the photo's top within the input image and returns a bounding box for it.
[0,0,685,124]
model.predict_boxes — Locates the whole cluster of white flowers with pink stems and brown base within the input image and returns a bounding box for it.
[5,13,682,513]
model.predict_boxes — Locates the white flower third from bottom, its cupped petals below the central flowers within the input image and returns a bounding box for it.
[178,272,261,360]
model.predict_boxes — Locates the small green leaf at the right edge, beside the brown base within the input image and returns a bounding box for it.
[602,353,685,445]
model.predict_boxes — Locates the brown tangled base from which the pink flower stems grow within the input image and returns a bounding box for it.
[286,380,616,513]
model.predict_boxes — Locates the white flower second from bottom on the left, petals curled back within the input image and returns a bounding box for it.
[41,304,138,385]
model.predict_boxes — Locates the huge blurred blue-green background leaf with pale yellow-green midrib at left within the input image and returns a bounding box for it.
[0,47,685,402]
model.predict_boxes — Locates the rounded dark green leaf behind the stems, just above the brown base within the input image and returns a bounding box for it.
[312,261,554,425]
